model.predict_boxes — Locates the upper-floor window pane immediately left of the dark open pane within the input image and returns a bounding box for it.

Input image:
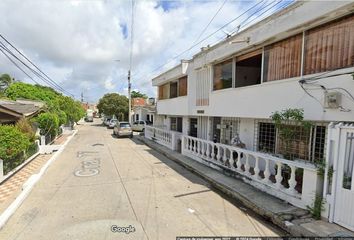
[213,60,232,90]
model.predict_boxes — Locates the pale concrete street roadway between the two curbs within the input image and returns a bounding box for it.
[0,119,284,240]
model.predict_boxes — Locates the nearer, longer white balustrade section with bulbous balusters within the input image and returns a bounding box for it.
[182,135,317,207]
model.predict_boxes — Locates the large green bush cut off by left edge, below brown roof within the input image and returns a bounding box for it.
[0,125,31,174]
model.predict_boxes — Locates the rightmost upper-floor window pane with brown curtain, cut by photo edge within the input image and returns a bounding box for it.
[304,14,354,74]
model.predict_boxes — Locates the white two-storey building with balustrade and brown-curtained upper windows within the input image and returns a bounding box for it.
[145,1,354,230]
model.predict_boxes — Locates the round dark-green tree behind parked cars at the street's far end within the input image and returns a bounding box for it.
[97,93,129,120]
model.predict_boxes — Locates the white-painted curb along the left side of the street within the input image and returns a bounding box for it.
[0,130,78,229]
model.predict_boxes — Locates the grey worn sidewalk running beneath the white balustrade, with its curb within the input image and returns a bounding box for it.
[134,135,354,237]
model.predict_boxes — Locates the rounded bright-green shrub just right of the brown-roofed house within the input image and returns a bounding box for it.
[34,113,59,137]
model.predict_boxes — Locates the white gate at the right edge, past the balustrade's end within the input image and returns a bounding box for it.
[334,128,354,231]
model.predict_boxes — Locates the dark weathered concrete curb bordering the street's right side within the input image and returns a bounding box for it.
[136,136,316,237]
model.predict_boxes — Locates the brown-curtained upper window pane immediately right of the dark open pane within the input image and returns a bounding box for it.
[263,34,302,82]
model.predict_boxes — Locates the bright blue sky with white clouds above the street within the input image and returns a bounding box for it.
[0,0,294,103]
